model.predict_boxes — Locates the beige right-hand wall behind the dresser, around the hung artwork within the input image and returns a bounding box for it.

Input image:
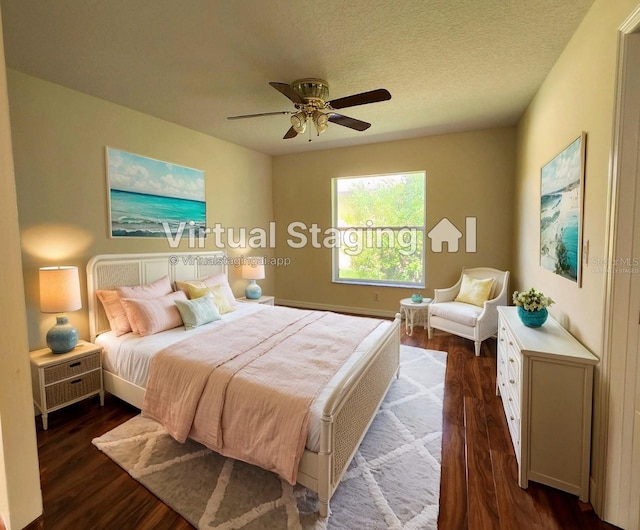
[513,0,637,516]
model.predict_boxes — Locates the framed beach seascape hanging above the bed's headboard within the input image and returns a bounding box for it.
[107,147,206,240]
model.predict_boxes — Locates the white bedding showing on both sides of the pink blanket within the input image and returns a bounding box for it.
[96,302,391,451]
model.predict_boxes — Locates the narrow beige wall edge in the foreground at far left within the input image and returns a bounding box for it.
[0,13,42,530]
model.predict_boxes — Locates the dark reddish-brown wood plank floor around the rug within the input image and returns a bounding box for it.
[37,329,615,530]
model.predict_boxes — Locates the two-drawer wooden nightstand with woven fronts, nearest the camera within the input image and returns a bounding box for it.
[29,340,104,431]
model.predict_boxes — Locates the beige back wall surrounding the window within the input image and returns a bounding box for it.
[273,128,515,314]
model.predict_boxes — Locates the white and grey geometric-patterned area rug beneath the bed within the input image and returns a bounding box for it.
[93,345,447,530]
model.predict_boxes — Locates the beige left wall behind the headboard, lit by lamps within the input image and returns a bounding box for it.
[8,70,275,349]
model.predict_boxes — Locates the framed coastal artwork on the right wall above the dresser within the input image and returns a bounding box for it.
[540,132,587,286]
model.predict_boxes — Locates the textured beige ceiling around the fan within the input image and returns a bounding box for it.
[0,0,593,155]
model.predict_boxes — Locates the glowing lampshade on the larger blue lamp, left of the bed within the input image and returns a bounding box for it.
[40,267,82,313]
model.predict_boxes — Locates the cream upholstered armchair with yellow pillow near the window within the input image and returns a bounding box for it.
[428,267,509,355]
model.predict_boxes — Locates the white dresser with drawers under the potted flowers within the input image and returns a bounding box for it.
[496,307,599,502]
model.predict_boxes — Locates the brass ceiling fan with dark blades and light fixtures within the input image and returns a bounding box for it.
[227,78,391,141]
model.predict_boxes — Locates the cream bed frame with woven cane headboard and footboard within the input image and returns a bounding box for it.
[87,251,400,517]
